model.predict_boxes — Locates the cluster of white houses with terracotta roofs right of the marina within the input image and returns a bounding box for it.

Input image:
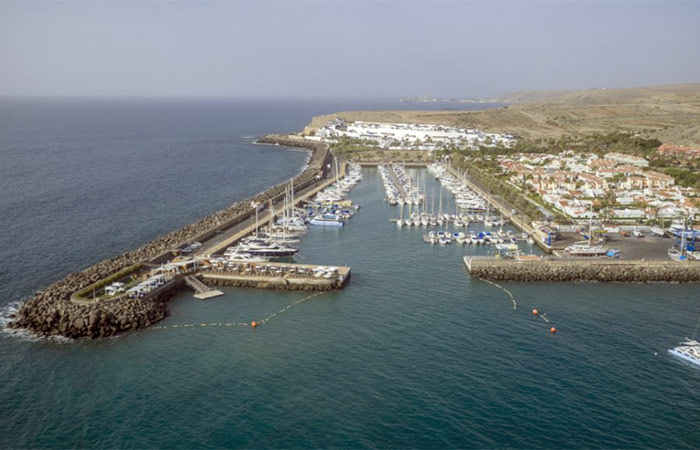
[497,151,700,223]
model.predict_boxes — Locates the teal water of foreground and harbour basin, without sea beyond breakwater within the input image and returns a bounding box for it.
[0,169,700,448]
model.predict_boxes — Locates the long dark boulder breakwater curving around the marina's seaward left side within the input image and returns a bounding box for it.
[8,136,329,338]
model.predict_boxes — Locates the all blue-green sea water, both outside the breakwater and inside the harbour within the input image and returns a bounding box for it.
[0,100,700,448]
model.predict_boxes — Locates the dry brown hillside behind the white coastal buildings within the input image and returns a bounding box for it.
[304,83,700,145]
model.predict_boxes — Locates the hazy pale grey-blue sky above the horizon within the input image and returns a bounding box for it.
[0,1,700,98]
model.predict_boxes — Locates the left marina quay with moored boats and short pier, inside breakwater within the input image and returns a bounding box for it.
[71,158,362,304]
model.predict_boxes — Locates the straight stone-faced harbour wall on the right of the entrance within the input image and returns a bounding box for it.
[464,257,700,283]
